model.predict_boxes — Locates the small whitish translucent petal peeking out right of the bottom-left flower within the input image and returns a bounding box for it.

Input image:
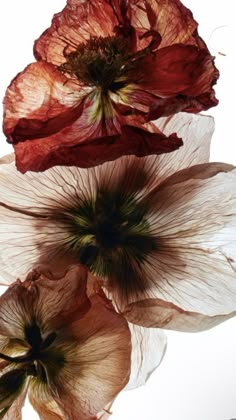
[125,324,167,390]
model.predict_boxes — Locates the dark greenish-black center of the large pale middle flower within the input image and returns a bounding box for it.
[63,189,157,288]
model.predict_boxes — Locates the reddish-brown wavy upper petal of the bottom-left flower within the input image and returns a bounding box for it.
[0,266,90,340]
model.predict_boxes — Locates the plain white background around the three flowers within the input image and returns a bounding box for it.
[0,0,236,420]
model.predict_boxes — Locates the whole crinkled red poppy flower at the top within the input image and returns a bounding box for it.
[4,0,218,173]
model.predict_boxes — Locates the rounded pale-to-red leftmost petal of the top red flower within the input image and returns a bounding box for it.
[4,62,87,143]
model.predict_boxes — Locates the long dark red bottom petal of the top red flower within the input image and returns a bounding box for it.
[14,124,183,173]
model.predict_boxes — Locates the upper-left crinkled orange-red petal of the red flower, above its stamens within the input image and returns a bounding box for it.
[34,0,122,65]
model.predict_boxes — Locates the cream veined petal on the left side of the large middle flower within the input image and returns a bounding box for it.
[0,164,92,284]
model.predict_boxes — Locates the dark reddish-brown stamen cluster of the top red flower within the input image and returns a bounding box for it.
[59,36,132,91]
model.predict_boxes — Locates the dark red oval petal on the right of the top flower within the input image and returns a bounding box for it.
[132,44,218,99]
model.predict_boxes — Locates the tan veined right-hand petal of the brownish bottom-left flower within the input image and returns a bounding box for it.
[49,295,131,420]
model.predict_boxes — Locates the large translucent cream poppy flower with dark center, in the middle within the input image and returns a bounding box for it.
[0,114,236,331]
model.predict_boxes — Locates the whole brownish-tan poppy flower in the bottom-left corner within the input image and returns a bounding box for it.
[0,266,131,420]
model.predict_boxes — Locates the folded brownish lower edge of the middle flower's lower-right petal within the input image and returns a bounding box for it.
[123,299,236,332]
